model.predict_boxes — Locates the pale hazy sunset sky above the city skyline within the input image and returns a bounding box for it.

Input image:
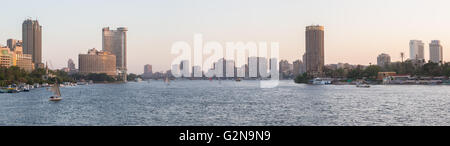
[0,0,450,74]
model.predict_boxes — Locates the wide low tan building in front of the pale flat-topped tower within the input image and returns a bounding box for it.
[78,48,117,76]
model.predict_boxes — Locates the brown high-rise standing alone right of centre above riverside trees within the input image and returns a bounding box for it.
[303,25,325,77]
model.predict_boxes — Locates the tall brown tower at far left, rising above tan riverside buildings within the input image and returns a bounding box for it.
[22,19,43,67]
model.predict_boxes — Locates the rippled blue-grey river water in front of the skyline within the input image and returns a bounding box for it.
[0,81,450,126]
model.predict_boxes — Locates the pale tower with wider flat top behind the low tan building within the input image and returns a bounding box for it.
[102,27,128,81]
